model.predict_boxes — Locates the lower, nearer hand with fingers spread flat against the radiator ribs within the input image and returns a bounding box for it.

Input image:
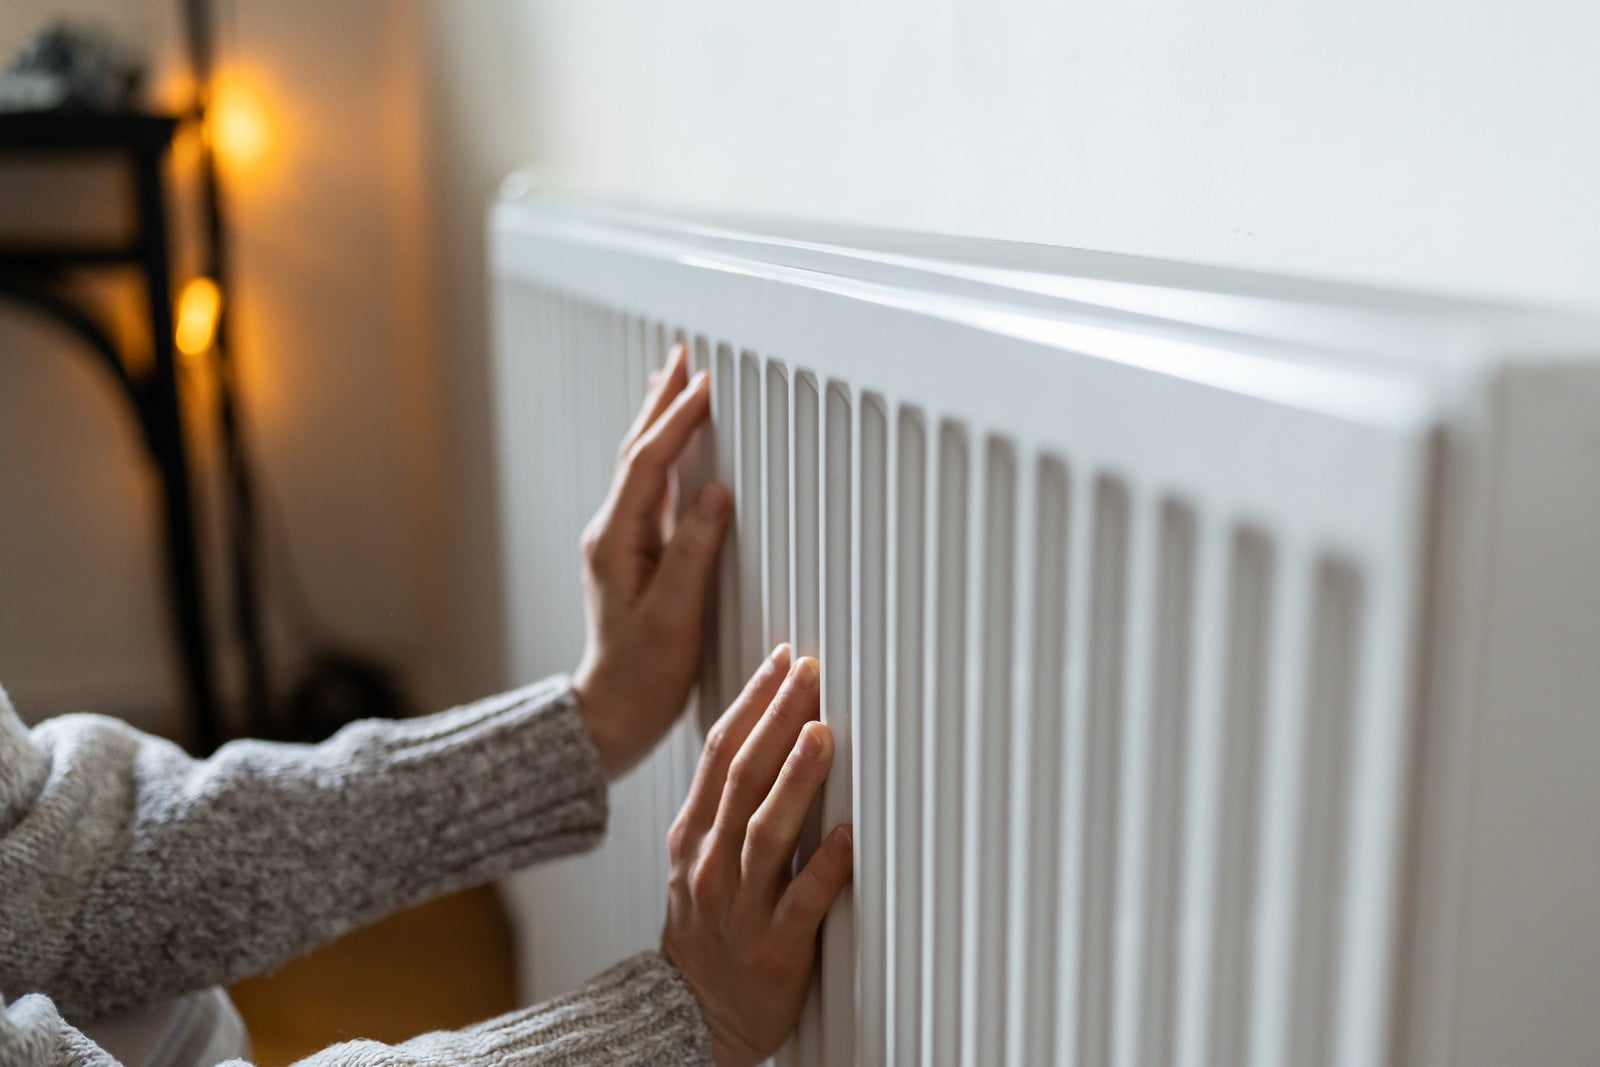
[661,646,853,1067]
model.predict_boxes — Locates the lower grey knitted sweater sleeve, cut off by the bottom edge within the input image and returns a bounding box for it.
[0,952,712,1067]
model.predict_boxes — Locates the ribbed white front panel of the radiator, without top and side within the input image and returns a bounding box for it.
[498,204,1430,1067]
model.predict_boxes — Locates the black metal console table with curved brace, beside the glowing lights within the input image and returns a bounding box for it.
[0,112,224,752]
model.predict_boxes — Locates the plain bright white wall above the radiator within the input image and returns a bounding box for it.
[435,0,1600,313]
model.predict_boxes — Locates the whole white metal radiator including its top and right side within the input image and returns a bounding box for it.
[491,198,1600,1067]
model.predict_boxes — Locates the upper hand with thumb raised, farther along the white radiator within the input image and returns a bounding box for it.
[573,346,730,779]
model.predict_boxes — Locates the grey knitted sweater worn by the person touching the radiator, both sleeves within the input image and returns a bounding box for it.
[0,678,710,1067]
